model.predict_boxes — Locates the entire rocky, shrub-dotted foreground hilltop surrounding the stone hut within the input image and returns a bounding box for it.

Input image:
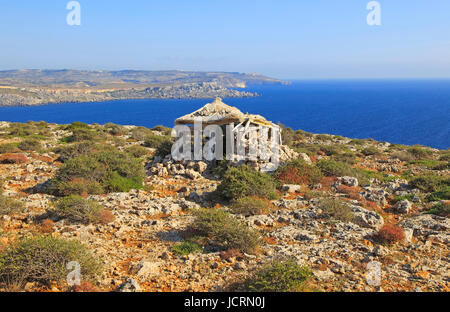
[0,122,450,291]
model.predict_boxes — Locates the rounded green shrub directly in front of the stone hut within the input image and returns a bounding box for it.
[215,165,277,200]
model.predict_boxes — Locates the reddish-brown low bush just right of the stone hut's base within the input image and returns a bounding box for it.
[275,159,322,185]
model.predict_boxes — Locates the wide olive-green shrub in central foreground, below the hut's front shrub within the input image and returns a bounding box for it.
[192,209,260,253]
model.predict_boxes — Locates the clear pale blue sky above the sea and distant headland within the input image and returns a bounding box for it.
[0,0,450,79]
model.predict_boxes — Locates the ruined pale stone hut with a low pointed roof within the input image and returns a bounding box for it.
[148,98,311,179]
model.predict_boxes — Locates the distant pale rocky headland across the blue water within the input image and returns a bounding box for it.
[0,70,286,106]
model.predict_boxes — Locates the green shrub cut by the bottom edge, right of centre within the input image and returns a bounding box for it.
[247,260,312,292]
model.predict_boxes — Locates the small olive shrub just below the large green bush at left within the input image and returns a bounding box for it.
[53,195,102,224]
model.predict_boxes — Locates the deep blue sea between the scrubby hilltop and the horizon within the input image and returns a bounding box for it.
[0,80,450,149]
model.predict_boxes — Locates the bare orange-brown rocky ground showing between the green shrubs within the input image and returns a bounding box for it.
[0,123,450,292]
